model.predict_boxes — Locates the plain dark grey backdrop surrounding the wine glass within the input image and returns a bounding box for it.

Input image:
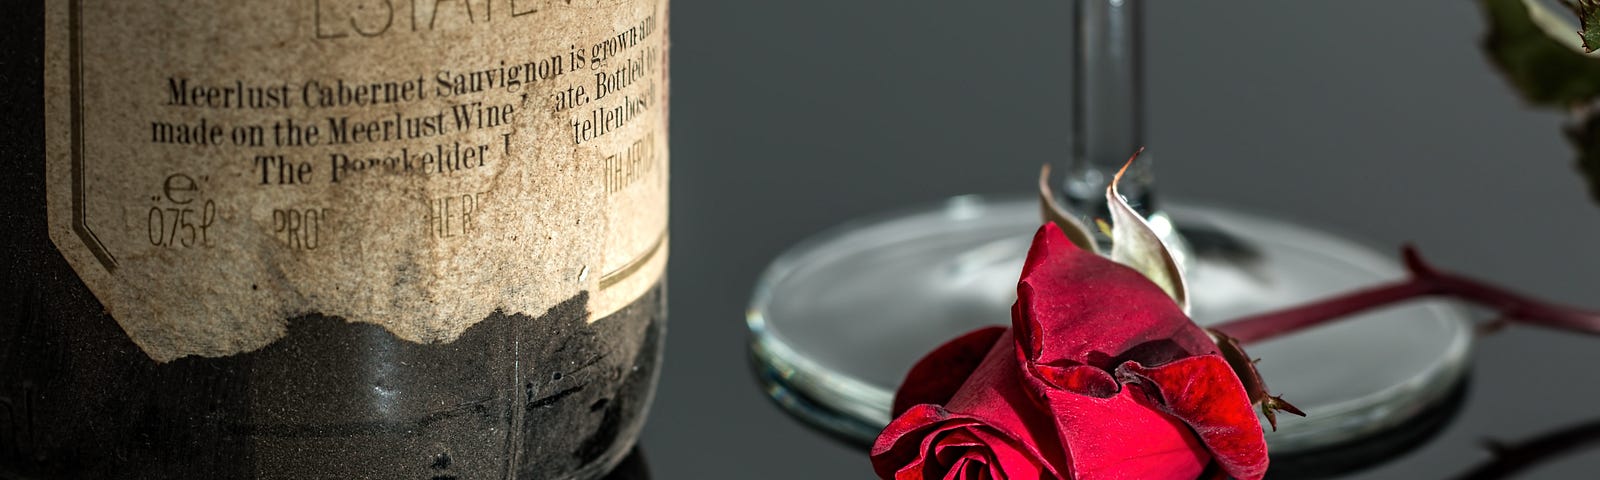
[643,0,1600,478]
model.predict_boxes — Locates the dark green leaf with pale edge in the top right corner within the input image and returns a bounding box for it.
[1480,0,1600,107]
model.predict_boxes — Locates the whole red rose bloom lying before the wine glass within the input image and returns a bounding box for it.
[872,224,1267,480]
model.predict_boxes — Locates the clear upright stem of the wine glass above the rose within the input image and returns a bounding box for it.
[1062,0,1155,221]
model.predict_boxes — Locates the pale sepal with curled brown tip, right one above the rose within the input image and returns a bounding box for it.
[1106,147,1189,314]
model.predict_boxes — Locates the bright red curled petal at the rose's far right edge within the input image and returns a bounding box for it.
[1117,355,1267,480]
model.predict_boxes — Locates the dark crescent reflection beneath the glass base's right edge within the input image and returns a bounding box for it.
[1267,379,1472,480]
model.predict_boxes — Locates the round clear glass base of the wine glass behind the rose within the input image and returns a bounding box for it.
[747,195,1472,454]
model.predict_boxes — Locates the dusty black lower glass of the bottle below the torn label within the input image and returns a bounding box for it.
[0,283,666,478]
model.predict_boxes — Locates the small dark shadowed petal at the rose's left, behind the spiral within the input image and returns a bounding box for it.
[890,326,1006,416]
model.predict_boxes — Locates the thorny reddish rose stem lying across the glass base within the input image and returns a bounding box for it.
[1213,245,1600,344]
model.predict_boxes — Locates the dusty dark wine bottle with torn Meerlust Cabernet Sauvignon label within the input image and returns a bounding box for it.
[0,0,669,478]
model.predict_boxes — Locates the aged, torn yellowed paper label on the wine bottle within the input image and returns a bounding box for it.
[45,0,667,362]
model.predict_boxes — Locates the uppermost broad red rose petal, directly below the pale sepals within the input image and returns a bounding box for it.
[1013,224,1216,371]
